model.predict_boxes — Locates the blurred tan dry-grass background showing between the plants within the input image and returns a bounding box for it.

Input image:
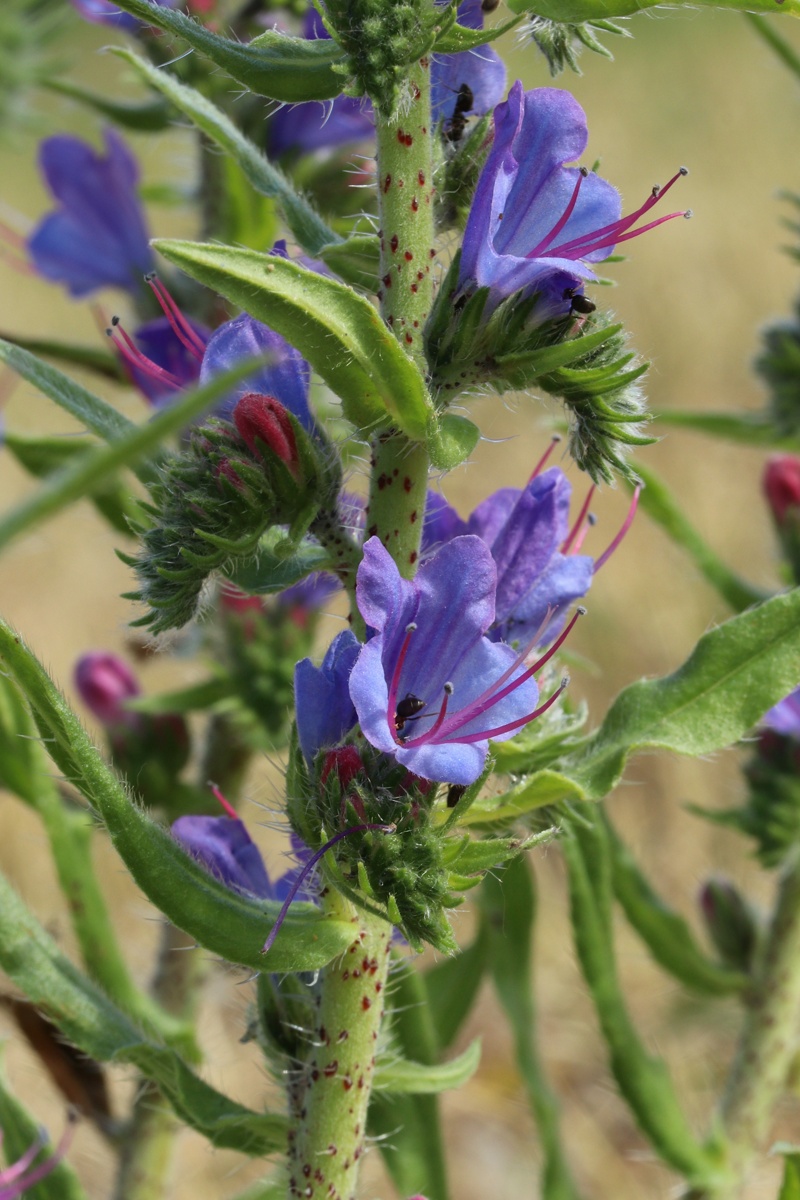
[0,11,800,1200]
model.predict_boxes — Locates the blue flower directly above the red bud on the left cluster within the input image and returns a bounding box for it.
[200,312,314,432]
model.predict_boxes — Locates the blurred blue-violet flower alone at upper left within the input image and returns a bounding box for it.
[28,130,154,296]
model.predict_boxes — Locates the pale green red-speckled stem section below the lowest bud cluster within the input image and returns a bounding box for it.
[289,890,392,1200]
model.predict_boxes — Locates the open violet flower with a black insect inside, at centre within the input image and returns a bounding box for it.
[350,536,575,785]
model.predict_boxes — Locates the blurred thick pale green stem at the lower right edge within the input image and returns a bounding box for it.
[718,856,800,1200]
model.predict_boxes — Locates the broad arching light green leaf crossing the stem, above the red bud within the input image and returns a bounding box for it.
[154,239,431,442]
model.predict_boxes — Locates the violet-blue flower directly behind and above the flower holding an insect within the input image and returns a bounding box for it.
[422,467,595,646]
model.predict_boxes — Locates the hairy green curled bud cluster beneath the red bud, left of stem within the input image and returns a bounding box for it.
[120,414,341,632]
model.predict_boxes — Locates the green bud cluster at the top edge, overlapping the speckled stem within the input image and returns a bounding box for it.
[325,0,448,118]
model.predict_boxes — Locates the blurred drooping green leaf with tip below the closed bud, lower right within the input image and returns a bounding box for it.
[606,820,747,996]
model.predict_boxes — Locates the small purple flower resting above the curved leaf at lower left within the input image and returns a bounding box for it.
[173,816,275,900]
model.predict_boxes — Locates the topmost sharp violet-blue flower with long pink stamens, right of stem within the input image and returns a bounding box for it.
[459,80,688,322]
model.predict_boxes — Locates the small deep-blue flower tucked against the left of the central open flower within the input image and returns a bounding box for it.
[295,629,361,766]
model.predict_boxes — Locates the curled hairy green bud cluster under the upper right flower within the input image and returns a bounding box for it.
[425,256,654,482]
